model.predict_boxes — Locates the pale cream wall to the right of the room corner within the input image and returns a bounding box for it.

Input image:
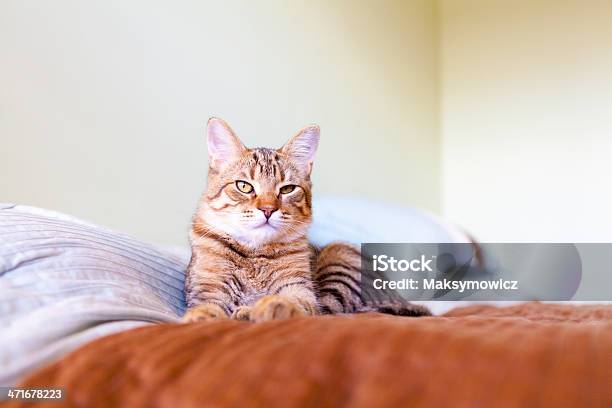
[440,0,612,242]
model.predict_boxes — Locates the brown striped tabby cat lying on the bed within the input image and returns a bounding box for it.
[183,118,428,322]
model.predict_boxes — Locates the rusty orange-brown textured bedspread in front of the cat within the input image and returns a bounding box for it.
[5,303,612,407]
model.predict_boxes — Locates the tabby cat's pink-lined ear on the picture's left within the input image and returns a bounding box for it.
[206,118,246,169]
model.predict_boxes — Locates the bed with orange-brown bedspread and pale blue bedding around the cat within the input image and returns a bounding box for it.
[0,199,612,407]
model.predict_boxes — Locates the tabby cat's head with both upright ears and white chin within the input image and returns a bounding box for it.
[196,118,319,247]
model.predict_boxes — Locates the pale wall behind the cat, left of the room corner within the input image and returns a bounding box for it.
[0,0,440,244]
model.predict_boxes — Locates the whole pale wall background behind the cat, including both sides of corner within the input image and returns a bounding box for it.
[0,0,612,245]
